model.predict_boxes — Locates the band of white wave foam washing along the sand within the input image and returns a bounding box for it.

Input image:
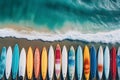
[0,28,120,43]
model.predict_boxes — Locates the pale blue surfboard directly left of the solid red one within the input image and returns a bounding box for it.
[103,46,110,80]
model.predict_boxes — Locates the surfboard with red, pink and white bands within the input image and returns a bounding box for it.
[55,44,61,79]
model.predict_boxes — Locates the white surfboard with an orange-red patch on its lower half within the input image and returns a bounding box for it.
[98,46,103,80]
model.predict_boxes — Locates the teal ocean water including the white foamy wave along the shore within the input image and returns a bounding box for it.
[0,0,120,43]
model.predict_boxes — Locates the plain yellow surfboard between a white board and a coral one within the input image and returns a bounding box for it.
[26,47,33,79]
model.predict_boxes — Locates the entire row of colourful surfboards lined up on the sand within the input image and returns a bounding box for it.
[0,44,120,80]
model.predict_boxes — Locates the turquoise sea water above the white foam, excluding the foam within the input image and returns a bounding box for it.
[0,0,120,32]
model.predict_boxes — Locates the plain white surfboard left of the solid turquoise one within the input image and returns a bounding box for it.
[5,46,12,79]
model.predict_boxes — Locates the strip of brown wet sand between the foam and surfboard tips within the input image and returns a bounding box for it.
[0,37,120,79]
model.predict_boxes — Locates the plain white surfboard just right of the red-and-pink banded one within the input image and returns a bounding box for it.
[62,45,68,80]
